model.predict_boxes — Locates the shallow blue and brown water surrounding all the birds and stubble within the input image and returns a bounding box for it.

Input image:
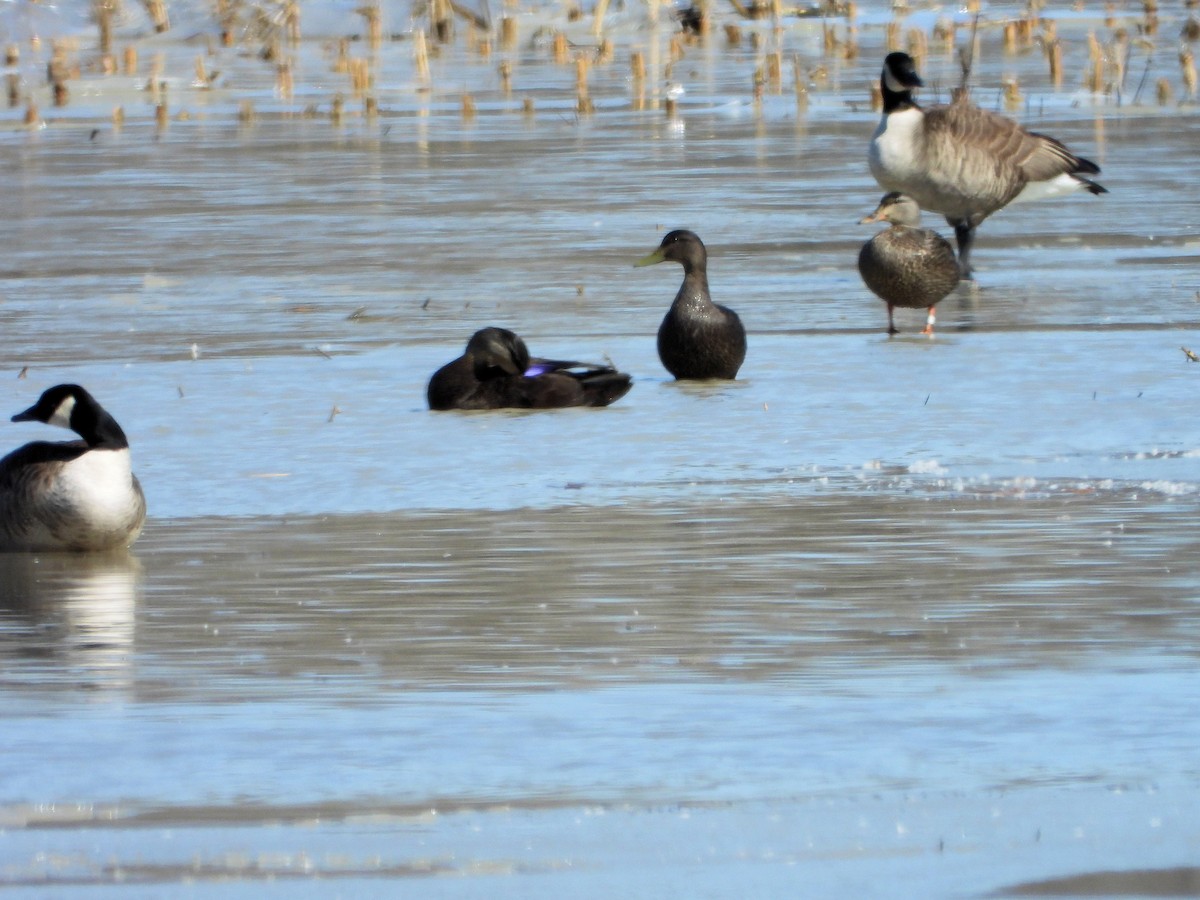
[0,4,1200,898]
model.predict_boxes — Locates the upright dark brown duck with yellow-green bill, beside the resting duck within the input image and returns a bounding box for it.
[634,230,746,379]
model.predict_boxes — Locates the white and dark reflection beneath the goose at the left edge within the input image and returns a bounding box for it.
[0,552,142,690]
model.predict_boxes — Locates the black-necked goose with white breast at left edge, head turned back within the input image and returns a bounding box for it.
[0,384,146,551]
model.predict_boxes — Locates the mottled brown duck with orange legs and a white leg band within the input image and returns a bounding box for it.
[858,191,959,335]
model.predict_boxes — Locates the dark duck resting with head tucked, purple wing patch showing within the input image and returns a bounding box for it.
[426,328,631,409]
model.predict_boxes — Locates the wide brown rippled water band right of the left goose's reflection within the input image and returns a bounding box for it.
[112,492,1200,698]
